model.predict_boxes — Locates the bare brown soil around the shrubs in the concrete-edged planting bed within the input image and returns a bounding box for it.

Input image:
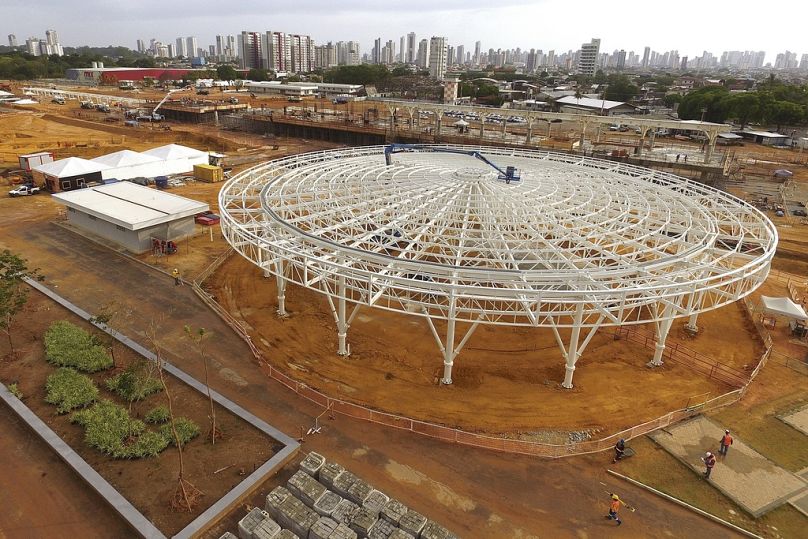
[0,292,279,535]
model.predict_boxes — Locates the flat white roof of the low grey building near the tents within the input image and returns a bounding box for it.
[53,182,210,230]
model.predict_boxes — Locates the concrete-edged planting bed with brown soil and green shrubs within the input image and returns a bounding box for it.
[0,294,281,535]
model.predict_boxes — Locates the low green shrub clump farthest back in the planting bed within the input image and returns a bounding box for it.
[45,320,112,372]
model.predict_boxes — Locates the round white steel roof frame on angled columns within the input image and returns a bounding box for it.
[219,145,777,388]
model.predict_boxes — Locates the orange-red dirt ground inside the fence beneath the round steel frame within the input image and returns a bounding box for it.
[209,256,762,442]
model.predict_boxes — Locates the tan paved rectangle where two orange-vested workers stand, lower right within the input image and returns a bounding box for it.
[651,416,808,518]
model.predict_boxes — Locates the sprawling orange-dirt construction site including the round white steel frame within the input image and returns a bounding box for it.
[0,80,808,538]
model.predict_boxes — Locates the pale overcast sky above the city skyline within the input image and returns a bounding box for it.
[0,0,808,62]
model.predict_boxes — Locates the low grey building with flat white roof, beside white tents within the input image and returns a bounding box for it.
[53,182,210,253]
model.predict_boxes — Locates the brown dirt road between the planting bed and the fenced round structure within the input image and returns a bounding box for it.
[2,221,731,538]
